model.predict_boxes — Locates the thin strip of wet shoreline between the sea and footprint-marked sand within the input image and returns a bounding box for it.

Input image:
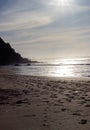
[0,66,90,81]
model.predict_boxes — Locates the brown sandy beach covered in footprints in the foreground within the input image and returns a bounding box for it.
[0,69,90,130]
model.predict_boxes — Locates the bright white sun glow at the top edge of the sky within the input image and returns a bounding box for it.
[47,0,76,13]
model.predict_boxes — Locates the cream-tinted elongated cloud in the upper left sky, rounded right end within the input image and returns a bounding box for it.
[0,13,52,31]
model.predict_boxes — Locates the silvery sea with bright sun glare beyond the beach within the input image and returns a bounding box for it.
[5,58,90,78]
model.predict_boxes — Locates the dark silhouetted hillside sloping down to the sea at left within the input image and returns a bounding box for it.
[0,38,30,65]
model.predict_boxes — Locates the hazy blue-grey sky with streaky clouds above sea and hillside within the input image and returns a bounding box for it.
[0,0,90,60]
